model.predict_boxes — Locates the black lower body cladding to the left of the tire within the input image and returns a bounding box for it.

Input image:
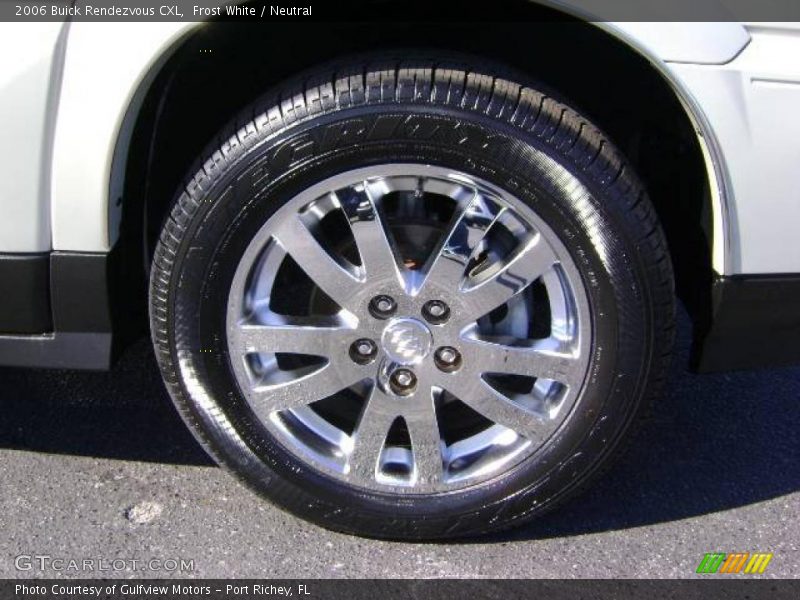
[0,246,146,370]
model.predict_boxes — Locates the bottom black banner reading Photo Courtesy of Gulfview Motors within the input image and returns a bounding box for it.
[0,577,800,600]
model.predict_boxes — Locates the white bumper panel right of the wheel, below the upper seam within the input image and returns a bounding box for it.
[669,25,800,273]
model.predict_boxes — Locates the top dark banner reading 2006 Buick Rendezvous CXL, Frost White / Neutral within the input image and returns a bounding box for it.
[0,0,800,23]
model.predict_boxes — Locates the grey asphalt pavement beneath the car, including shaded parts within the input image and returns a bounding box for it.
[0,318,800,578]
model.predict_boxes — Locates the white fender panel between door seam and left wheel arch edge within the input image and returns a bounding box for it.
[51,22,191,252]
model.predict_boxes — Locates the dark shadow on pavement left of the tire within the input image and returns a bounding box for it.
[0,339,213,465]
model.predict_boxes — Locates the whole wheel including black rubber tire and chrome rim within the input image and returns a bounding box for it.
[150,59,674,540]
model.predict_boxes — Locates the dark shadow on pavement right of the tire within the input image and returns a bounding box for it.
[484,314,800,541]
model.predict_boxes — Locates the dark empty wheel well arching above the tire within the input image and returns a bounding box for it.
[118,12,713,346]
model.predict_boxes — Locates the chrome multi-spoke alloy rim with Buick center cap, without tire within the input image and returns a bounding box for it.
[226,164,592,494]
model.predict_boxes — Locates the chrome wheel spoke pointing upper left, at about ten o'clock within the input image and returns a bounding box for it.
[274,215,360,308]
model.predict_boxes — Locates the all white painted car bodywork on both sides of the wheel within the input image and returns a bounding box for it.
[0,16,800,275]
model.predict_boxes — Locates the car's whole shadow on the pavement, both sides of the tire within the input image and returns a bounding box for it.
[0,315,800,542]
